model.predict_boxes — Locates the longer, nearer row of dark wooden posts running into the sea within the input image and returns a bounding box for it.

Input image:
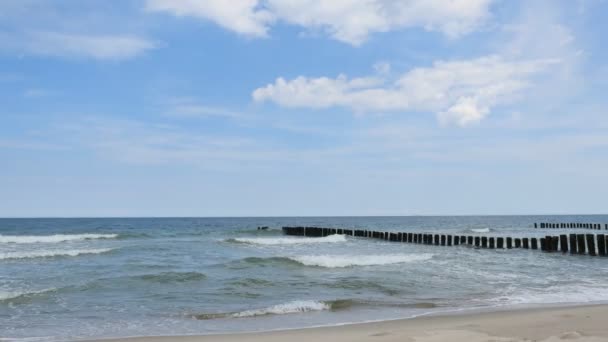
[283,227,608,256]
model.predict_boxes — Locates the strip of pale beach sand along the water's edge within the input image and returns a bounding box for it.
[94,305,608,342]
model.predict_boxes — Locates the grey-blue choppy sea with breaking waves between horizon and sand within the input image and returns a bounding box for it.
[0,215,608,341]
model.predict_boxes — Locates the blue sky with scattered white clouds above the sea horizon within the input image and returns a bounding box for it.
[0,0,608,217]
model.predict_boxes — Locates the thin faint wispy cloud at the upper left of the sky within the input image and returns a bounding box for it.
[11,31,156,60]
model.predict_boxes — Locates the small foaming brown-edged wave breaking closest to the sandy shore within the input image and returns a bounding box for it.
[194,300,332,320]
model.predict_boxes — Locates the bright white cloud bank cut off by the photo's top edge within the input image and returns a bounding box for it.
[146,0,493,45]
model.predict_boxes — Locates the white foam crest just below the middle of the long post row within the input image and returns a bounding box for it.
[289,253,433,268]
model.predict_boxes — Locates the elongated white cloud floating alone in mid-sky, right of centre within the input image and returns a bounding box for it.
[252,56,558,126]
